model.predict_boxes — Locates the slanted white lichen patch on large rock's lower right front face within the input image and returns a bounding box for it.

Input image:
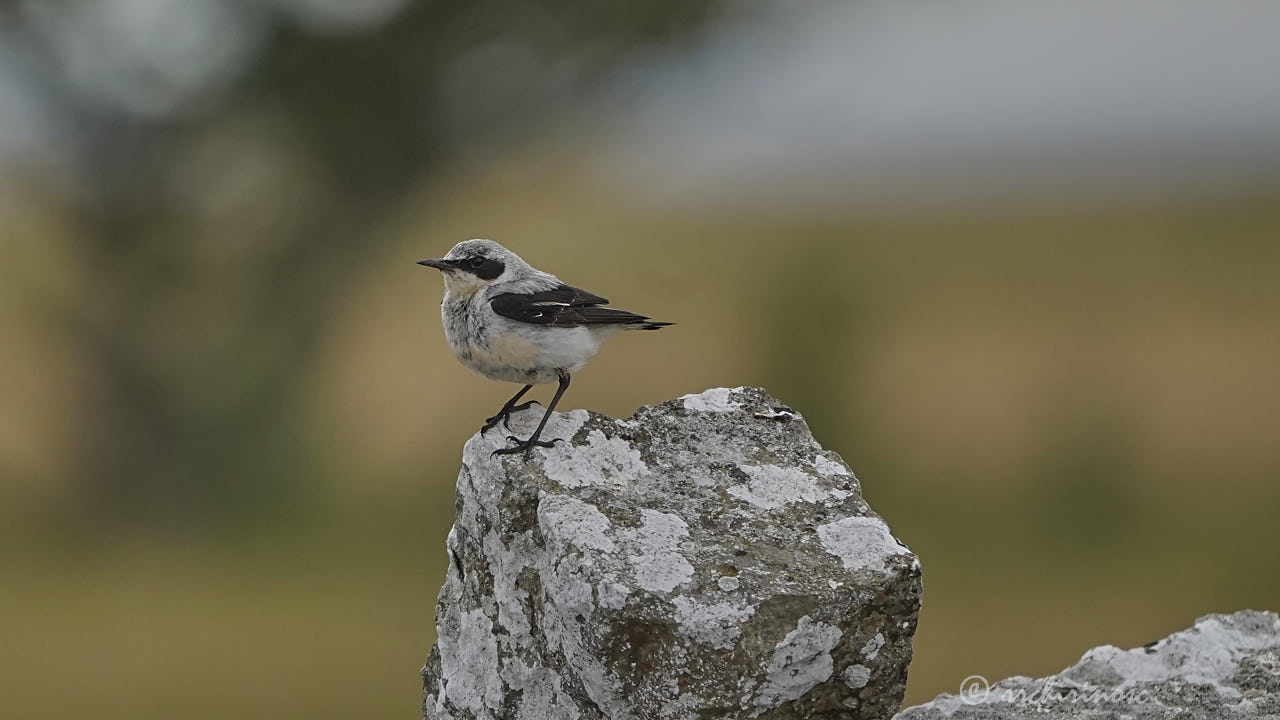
[755,615,844,715]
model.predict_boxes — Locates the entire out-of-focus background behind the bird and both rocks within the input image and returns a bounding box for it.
[0,0,1280,719]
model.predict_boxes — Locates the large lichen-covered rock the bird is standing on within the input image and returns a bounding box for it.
[424,388,920,720]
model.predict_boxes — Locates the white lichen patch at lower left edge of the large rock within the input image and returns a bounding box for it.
[439,610,502,715]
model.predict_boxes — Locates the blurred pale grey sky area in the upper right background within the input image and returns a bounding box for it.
[604,0,1280,202]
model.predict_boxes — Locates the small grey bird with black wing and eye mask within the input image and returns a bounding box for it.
[417,238,675,460]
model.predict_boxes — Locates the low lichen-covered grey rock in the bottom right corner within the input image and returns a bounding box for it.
[897,610,1280,720]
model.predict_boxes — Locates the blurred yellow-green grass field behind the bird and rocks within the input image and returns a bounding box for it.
[0,161,1280,719]
